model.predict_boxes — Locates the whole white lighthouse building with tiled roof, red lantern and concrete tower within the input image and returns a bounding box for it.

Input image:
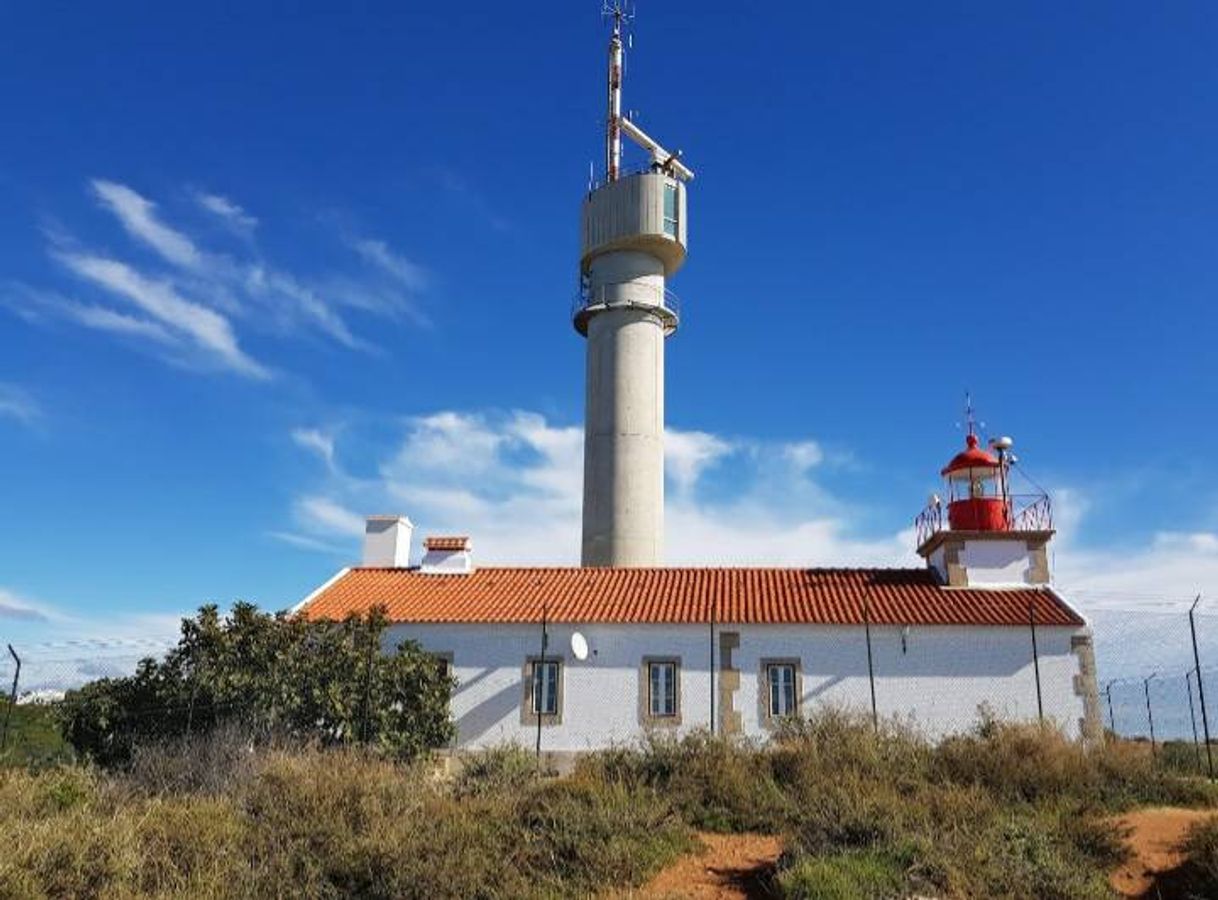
[296,15,1101,764]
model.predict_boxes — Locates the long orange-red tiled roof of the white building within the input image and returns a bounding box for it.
[302,568,1084,626]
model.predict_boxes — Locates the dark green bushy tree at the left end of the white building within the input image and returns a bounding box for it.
[58,603,454,765]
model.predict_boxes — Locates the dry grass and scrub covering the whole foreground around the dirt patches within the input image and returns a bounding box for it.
[0,715,1218,900]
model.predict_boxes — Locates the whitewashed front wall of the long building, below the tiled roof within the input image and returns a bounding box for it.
[385,624,1083,751]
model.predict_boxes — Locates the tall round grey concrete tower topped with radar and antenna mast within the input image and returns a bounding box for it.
[574,4,693,566]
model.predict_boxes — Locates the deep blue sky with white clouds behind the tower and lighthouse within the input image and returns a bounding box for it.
[0,0,1218,662]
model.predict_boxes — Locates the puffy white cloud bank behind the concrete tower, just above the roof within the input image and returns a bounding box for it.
[285,410,918,565]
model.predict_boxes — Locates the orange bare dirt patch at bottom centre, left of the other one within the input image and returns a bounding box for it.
[631,833,782,900]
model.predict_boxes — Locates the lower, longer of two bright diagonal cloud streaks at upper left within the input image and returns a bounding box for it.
[57,253,269,379]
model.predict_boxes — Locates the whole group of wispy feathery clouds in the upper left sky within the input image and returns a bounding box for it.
[8,178,430,379]
